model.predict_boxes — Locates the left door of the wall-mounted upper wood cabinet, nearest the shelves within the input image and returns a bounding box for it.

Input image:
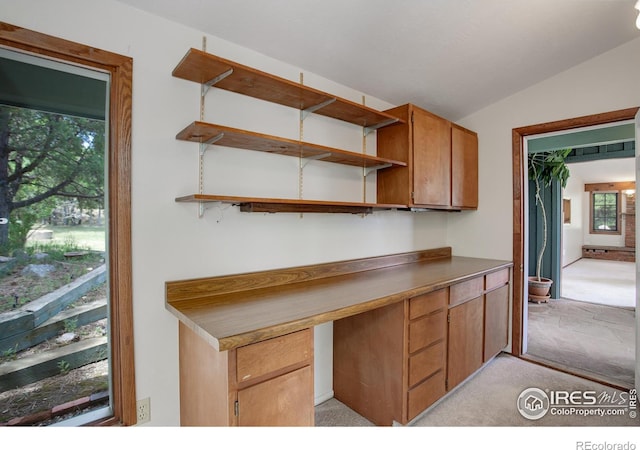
[413,108,451,206]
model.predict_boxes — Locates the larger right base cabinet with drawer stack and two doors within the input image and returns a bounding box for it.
[333,269,510,425]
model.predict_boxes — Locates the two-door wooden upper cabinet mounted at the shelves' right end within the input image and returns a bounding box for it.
[377,104,478,210]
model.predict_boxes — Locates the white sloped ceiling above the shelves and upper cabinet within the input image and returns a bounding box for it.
[121,0,640,121]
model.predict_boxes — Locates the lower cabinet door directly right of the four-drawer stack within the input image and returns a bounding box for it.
[447,296,484,390]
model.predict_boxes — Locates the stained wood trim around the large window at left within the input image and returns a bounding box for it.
[0,22,136,425]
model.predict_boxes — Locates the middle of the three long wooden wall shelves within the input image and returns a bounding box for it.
[176,121,407,170]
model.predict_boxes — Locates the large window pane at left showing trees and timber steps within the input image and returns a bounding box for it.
[0,52,112,425]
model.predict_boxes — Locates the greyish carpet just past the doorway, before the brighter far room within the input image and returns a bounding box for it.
[527,299,636,387]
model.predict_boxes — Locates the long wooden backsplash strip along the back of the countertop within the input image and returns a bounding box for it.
[165,247,451,303]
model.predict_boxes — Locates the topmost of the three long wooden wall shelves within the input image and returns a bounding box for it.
[173,48,399,129]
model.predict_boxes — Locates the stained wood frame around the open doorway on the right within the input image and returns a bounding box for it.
[511,107,639,356]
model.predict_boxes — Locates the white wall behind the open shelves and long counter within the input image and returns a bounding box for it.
[0,0,447,425]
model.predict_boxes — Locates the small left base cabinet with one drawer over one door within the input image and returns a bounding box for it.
[179,322,314,426]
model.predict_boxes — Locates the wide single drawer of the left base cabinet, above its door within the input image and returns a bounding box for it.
[236,328,313,383]
